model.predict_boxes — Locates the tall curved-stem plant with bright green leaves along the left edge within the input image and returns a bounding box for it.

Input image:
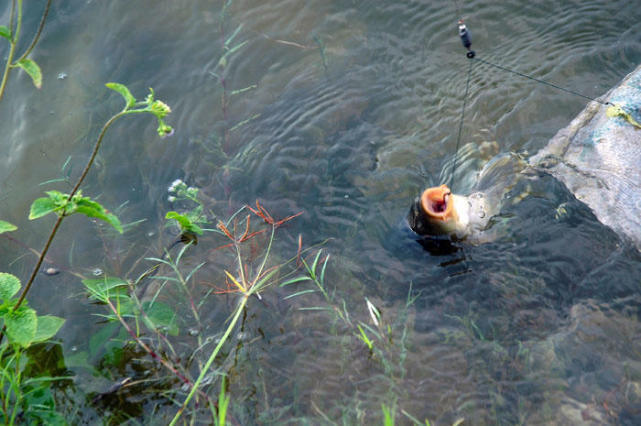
[0,83,173,424]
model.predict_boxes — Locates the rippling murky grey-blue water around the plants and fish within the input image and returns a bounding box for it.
[0,0,641,424]
